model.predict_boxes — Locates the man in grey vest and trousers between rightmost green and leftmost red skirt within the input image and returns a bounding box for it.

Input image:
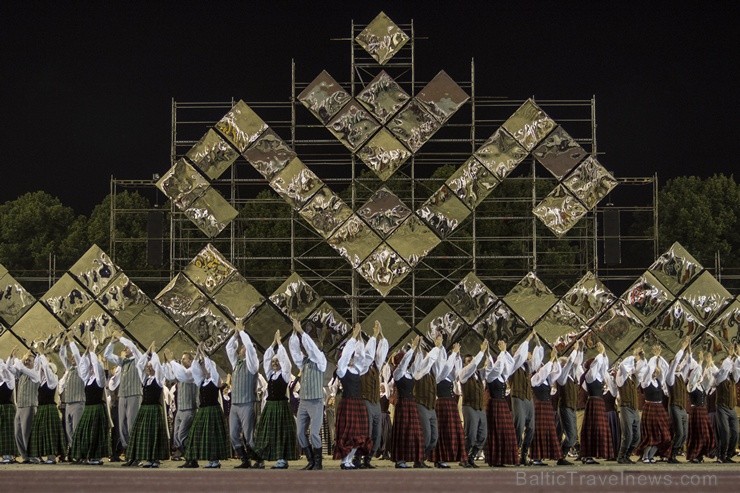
[288,320,326,471]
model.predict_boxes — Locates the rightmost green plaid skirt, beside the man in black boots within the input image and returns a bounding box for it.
[253,400,298,460]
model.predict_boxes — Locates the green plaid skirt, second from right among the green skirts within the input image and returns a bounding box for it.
[185,406,231,460]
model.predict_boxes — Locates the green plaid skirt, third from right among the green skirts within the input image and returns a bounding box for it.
[126,404,170,461]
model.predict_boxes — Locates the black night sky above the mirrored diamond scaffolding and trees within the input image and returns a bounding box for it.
[0,0,740,213]
